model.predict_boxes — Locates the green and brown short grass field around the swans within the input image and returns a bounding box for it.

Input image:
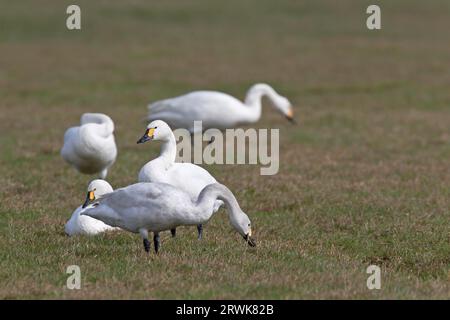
[0,0,450,299]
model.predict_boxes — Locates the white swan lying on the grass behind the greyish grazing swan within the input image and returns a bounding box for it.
[65,179,117,236]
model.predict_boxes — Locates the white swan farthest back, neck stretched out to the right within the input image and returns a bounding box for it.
[148,83,294,134]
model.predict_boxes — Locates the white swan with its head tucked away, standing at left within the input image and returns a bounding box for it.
[61,113,117,179]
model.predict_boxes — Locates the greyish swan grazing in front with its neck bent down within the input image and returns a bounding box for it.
[81,183,256,253]
